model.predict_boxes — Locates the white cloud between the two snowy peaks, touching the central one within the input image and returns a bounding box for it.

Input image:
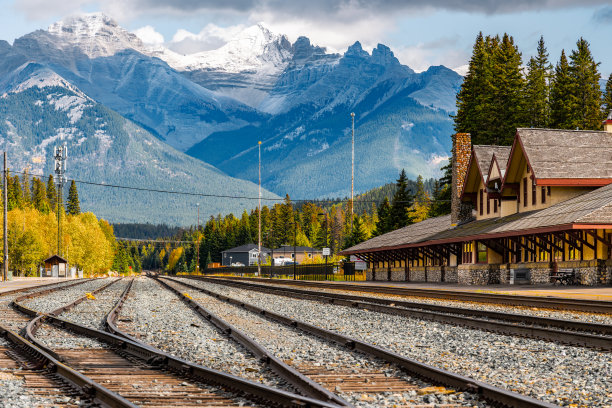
[166,23,245,54]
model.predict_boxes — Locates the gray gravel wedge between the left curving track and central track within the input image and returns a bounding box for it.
[118,278,295,392]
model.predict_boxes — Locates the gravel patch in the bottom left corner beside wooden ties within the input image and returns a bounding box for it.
[0,337,79,408]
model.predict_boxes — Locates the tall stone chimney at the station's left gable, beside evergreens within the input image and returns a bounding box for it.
[451,133,472,226]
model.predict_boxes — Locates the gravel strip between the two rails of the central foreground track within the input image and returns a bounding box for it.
[166,278,487,407]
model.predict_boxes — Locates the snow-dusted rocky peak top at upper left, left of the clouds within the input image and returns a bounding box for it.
[47,13,144,58]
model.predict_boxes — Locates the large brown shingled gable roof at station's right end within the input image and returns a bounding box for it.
[504,128,612,186]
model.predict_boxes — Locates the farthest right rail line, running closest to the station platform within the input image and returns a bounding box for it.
[207,276,612,314]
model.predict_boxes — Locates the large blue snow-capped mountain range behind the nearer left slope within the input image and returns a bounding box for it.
[0,13,462,212]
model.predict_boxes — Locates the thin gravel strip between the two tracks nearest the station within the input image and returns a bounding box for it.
[232,282,612,325]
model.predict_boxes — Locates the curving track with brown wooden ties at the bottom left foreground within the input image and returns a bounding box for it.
[13,276,344,407]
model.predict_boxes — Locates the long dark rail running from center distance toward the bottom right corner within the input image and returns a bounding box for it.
[165,278,558,408]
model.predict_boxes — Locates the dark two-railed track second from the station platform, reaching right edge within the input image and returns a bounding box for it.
[197,277,612,351]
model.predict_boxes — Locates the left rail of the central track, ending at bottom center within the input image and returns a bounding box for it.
[154,278,352,407]
